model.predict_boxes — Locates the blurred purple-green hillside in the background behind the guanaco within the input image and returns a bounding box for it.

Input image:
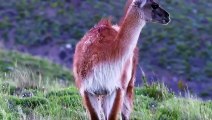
[0,0,212,99]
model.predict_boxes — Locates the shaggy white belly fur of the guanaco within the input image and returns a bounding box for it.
[80,56,132,94]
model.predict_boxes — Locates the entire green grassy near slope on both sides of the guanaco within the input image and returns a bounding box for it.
[0,51,212,120]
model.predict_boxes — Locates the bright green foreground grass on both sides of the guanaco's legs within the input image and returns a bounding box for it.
[0,80,212,120]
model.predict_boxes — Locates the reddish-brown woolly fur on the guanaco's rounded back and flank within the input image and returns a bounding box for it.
[74,19,117,86]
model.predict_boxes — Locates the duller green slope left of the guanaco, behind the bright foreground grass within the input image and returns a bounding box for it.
[0,49,73,85]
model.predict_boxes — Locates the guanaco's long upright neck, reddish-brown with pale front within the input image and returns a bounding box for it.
[117,6,146,55]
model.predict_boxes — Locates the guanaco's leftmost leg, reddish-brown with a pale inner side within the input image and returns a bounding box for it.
[82,91,102,120]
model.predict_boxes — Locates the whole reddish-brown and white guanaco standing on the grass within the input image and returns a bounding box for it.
[73,0,170,120]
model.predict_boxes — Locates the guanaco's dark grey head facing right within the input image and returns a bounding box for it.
[125,0,170,24]
